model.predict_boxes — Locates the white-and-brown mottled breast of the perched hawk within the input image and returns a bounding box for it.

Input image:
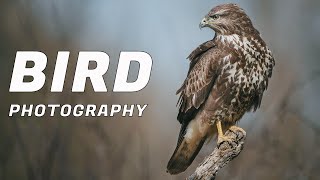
[217,35,273,93]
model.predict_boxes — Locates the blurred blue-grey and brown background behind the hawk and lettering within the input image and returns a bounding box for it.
[0,0,320,180]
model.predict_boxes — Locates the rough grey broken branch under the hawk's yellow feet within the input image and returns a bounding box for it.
[187,130,246,180]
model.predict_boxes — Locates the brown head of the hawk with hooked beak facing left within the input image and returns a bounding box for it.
[199,4,256,35]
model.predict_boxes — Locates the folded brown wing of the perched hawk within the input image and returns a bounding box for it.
[177,40,221,125]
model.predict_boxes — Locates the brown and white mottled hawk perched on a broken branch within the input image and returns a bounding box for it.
[167,4,275,174]
